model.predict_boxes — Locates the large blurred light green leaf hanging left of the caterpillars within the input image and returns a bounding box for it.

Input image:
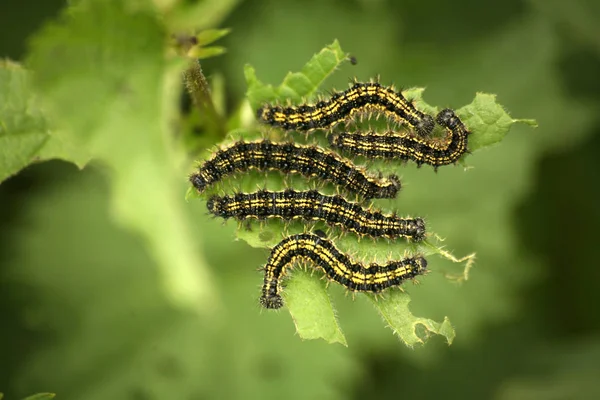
[28,0,213,309]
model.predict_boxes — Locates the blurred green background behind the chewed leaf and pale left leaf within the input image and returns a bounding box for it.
[0,0,600,400]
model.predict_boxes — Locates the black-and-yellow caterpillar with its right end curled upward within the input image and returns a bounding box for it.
[329,109,470,169]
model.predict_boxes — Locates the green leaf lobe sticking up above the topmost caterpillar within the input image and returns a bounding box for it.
[244,40,348,109]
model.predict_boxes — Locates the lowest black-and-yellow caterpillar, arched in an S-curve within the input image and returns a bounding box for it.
[260,233,427,309]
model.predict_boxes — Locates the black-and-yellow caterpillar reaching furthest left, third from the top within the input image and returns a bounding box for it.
[189,140,400,199]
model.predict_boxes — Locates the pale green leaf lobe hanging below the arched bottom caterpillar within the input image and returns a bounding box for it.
[283,267,348,346]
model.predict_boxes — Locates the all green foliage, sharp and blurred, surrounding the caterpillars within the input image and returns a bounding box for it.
[0,0,600,400]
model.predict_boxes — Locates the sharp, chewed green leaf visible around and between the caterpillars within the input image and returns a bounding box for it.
[237,41,535,346]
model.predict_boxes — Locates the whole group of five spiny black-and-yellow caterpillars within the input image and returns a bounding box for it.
[190,82,470,309]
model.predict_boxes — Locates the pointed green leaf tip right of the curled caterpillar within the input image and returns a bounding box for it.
[456,93,537,152]
